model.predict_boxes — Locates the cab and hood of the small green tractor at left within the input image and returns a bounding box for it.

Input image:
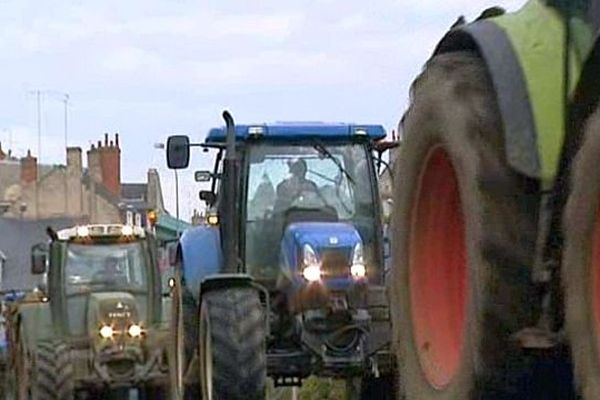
[40,225,160,339]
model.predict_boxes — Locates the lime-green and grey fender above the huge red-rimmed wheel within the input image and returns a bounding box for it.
[435,0,593,188]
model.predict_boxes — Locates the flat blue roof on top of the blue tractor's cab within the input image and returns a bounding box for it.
[206,122,386,143]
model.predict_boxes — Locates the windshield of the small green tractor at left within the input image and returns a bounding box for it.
[65,242,147,295]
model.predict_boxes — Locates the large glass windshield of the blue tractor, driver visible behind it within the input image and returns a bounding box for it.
[245,142,377,278]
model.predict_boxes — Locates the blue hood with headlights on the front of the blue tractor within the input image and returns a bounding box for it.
[281,222,362,290]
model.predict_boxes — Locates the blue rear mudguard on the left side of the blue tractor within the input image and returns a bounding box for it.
[179,226,223,301]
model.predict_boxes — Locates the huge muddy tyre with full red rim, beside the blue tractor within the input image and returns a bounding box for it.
[390,52,539,400]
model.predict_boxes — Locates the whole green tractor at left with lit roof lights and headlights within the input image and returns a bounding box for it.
[7,225,170,400]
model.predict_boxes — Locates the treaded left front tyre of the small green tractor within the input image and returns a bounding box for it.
[34,340,75,400]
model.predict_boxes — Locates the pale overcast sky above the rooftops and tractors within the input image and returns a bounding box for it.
[0,0,524,216]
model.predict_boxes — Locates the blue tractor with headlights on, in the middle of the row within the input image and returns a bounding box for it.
[167,112,395,400]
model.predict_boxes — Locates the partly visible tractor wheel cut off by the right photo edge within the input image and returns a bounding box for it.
[562,109,600,400]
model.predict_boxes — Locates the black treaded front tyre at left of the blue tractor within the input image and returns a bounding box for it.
[199,288,267,400]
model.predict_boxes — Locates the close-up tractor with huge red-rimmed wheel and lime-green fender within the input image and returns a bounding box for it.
[390,0,600,400]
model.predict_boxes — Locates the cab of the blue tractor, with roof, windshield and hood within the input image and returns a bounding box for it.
[202,124,385,288]
